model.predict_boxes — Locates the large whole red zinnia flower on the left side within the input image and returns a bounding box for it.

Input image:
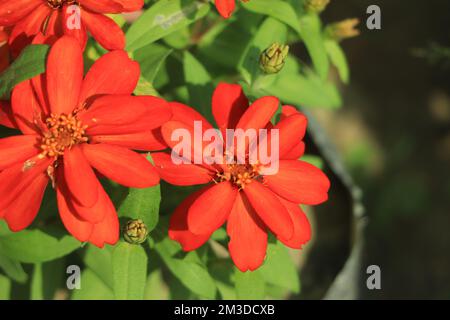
[0,36,172,247]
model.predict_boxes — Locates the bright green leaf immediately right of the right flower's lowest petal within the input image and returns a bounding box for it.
[258,242,300,293]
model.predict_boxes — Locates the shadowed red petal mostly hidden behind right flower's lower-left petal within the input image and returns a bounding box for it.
[169,189,211,251]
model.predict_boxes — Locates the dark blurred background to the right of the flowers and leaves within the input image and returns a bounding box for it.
[299,0,450,299]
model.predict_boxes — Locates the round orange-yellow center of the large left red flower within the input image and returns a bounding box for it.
[41,114,88,158]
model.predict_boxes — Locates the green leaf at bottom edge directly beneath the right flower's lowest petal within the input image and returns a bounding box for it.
[234,269,265,300]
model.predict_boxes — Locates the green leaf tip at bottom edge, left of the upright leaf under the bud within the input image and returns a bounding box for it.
[71,269,114,300]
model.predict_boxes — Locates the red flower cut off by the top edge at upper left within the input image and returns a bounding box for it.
[0,0,144,54]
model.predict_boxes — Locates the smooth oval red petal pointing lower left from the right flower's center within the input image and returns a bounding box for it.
[188,182,238,235]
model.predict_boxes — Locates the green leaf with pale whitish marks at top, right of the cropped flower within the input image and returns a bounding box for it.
[126,0,210,51]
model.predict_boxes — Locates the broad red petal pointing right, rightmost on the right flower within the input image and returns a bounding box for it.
[264,160,330,205]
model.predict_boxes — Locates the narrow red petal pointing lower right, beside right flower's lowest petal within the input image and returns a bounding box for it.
[244,181,294,239]
